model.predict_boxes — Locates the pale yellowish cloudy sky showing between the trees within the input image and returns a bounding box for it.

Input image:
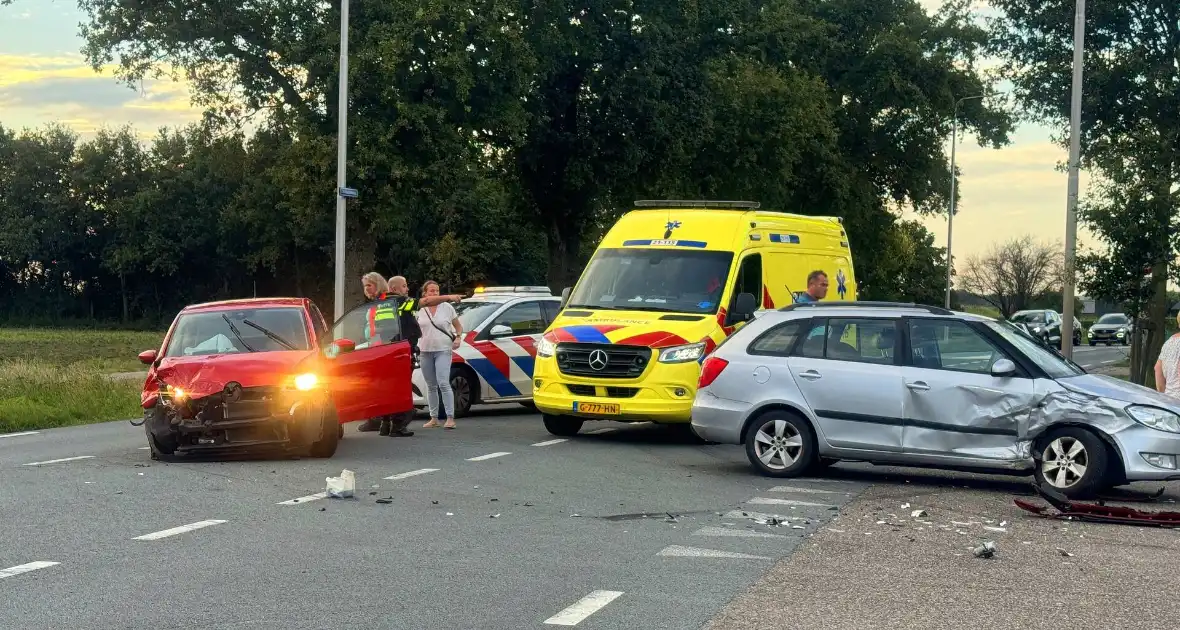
[0,0,1093,269]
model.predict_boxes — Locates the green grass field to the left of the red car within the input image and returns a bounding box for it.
[0,328,164,433]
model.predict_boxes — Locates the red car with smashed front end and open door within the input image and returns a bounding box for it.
[139,297,413,459]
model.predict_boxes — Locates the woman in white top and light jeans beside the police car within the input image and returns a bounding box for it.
[418,280,463,428]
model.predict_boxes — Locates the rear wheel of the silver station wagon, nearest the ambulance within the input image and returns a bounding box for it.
[746,409,817,477]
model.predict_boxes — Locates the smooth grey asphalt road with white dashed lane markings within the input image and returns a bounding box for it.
[0,406,868,630]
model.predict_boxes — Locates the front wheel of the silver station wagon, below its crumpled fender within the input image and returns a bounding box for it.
[1034,427,1110,499]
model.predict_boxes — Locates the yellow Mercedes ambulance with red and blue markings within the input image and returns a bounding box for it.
[532,201,857,435]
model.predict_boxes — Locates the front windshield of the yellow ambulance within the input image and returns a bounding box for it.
[569,248,733,313]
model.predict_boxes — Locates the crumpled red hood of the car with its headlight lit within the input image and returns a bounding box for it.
[152,350,315,398]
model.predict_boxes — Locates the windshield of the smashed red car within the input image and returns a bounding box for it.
[164,308,310,356]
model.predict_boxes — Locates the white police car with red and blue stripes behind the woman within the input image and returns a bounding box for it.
[413,287,562,416]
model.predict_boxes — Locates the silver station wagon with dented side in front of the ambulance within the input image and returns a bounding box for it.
[693,302,1180,497]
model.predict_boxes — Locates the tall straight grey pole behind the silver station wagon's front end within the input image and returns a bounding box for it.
[1061,0,1086,359]
